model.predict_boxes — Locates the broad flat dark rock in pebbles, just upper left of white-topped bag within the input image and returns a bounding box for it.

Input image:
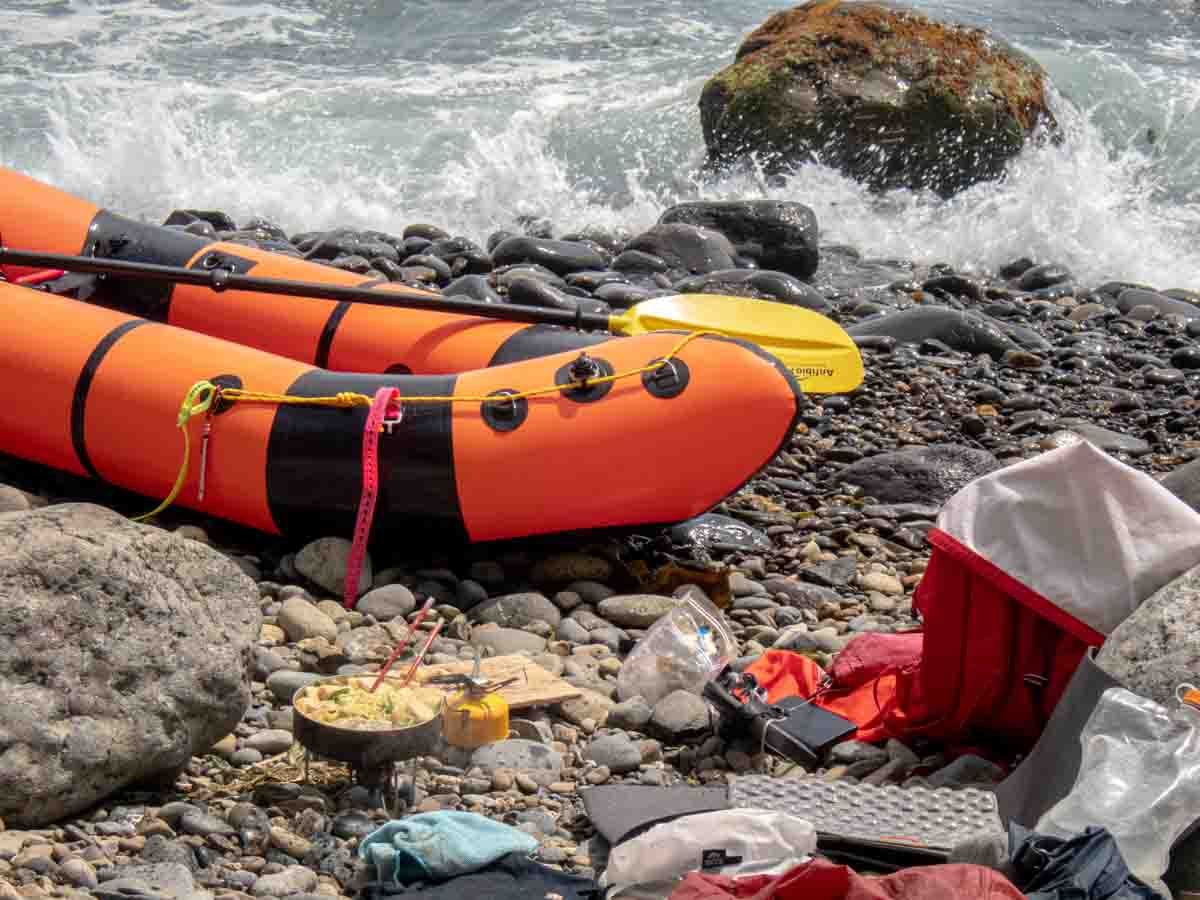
[838,444,1001,503]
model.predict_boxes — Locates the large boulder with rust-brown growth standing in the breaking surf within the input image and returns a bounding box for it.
[700,0,1057,196]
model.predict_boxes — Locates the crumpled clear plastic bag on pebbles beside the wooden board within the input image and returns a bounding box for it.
[617,596,737,706]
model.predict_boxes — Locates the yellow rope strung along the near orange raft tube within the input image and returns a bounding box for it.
[133,331,720,522]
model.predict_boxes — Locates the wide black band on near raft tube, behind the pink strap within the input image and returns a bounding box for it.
[266,370,469,545]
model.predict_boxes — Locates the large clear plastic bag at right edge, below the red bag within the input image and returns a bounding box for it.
[1034,685,1200,896]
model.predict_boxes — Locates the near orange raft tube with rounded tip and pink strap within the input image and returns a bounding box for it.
[0,284,799,542]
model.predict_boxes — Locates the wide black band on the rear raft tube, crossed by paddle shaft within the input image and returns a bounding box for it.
[79,210,211,322]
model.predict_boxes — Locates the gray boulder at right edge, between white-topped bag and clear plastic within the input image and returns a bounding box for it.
[1096,566,1200,708]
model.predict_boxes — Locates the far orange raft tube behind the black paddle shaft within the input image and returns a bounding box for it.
[0,167,620,374]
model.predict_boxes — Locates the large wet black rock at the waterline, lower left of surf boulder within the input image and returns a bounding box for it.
[659,200,820,278]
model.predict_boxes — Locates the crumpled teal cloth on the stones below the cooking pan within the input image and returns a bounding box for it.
[359,810,538,884]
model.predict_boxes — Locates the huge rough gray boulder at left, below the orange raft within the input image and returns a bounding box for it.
[0,503,262,828]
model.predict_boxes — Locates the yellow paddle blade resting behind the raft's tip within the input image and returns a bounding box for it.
[608,294,863,394]
